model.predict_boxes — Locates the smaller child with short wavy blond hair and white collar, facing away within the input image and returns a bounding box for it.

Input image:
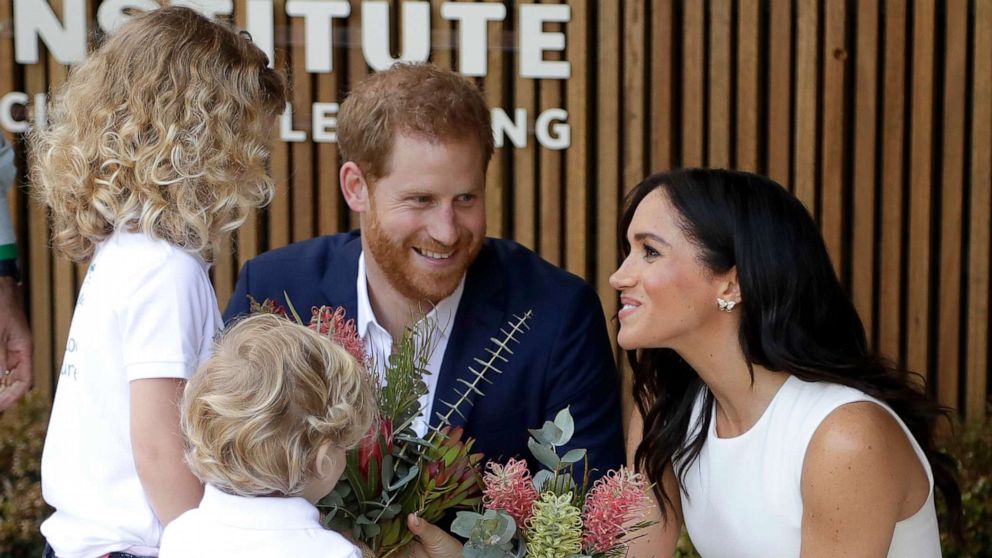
[159,314,375,558]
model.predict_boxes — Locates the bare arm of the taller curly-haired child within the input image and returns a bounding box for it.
[130,378,203,525]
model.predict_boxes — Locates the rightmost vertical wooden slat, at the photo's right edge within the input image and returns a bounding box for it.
[965,0,992,420]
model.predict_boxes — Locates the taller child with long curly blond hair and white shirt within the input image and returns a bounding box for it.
[31,7,286,558]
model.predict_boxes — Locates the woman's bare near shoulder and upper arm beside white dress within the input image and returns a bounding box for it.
[802,402,930,558]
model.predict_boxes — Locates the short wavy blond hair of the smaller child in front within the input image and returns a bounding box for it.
[182,314,376,496]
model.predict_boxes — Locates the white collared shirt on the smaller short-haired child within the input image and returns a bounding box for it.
[159,484,362,558]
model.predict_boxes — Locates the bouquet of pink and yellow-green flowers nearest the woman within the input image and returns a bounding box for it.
[451,408,651,558]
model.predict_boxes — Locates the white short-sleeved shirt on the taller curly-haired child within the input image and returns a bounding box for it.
[41,231,222,558]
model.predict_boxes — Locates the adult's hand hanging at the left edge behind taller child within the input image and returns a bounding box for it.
[0,277,34,412]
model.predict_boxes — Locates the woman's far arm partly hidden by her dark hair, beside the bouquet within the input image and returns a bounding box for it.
[627,408,682,558]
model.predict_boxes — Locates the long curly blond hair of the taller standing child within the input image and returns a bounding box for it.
[31,7,286,261]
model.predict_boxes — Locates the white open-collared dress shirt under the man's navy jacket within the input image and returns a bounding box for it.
[355,252,465,436]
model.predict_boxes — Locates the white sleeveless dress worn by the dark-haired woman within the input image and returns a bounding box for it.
[682,376,941,558]
